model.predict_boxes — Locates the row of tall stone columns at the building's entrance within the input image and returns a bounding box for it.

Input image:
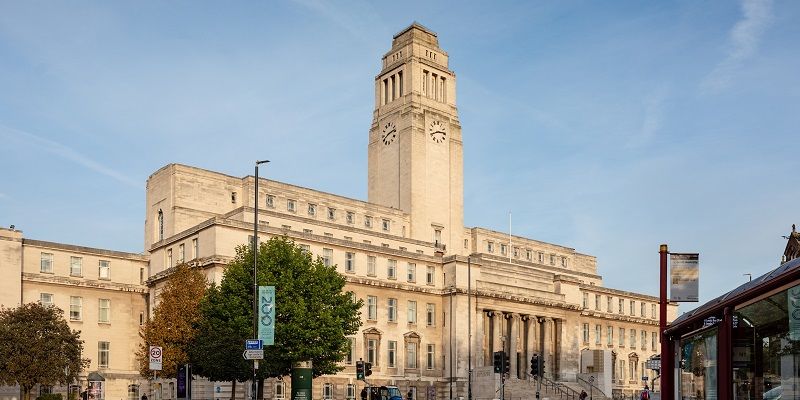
[476,309,562,379]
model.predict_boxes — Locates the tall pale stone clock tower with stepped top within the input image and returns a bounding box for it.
[368,22,464,254]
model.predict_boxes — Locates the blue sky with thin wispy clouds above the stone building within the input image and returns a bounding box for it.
[0,0,800,310]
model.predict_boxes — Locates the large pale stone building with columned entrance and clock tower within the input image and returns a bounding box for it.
[0,23,676,400]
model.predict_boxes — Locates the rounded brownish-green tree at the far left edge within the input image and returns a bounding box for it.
[0,303,89,400]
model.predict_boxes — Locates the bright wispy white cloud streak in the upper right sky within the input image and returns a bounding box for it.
[701,0,772,92]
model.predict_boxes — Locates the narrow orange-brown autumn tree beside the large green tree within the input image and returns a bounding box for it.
[136,264,208,378]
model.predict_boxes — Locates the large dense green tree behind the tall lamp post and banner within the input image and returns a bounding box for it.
[192,237,362,380]
